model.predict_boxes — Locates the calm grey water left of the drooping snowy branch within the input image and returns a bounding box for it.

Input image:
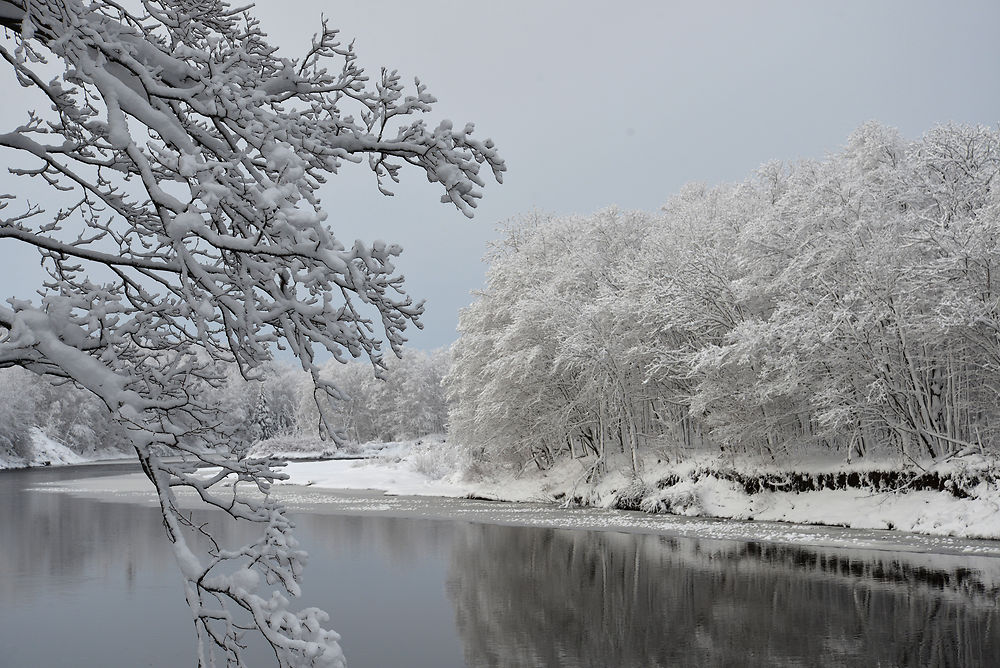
[0,468,194,668]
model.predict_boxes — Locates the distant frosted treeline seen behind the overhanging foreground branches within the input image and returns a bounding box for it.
[0,350,448,459]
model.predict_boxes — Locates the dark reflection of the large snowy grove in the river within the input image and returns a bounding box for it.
[448,525,1000,667]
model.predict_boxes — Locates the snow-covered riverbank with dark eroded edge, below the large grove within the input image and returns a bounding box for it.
[272,442,1000,540]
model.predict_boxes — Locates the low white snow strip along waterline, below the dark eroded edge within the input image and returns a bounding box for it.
[264,442,1000,540]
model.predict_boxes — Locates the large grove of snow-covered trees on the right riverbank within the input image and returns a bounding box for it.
[447,123,1000,470]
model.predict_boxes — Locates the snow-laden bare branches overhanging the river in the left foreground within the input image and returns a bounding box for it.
[0,0,504,666]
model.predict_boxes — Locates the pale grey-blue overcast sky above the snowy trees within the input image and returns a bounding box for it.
[0,0,1000,349]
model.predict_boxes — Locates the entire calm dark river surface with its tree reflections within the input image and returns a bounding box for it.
[0,466,1000,668]
